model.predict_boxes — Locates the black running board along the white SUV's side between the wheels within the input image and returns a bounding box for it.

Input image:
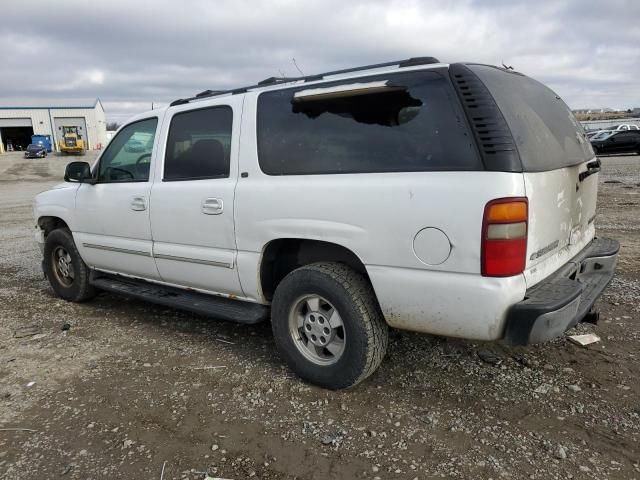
[90,271,269,324]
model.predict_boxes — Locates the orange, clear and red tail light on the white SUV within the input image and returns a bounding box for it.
[481,197,529,277]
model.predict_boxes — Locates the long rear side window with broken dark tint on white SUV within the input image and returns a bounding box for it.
[258,72,482,175]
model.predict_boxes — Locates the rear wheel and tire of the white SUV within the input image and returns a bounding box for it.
[271,263,389,390]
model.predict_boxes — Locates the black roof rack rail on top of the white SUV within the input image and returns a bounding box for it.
[169,57,440,107]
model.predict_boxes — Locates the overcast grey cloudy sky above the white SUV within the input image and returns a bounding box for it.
[0,0,640,122]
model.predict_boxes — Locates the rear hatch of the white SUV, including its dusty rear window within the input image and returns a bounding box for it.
[468,65,599,287]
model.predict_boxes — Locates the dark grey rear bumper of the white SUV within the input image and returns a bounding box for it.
[504,238,620,345]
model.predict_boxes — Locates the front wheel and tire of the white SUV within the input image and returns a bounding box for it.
[43,228,96,302]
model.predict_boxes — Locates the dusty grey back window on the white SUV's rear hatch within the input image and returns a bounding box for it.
[468,65,594,172]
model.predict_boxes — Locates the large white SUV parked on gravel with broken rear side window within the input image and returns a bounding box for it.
[34,57,619,388]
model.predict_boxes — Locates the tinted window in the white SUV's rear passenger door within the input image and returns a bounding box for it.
[164,107,233,181]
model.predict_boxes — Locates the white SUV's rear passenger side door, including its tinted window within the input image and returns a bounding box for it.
[151,95,244,296]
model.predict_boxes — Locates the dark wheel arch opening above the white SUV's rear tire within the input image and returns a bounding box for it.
[258,238,371,301]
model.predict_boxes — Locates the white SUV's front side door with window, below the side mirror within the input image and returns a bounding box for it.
[73,116,160,279]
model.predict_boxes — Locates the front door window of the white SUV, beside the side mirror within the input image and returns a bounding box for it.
[98,118,158,183]
